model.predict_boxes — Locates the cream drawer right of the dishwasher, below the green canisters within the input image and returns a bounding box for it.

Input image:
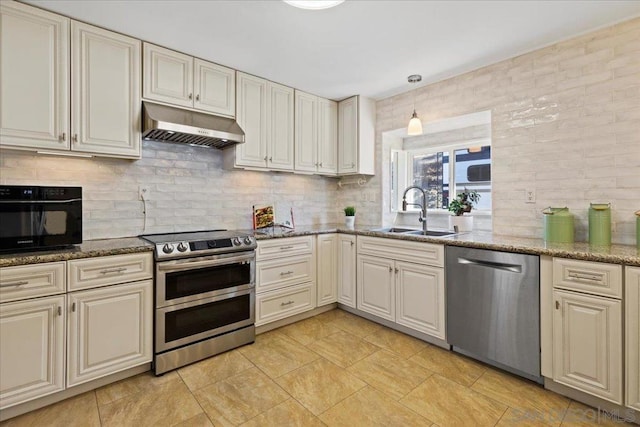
[553,258,622,298]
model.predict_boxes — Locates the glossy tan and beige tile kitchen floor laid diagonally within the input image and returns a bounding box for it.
[2,310,636,427]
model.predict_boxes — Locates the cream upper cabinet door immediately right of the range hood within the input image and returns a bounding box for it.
[235,72,267,168]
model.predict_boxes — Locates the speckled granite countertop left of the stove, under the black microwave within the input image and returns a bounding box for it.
[0,237,153,267]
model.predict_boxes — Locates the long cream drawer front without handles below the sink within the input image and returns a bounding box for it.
[358,236,444,267]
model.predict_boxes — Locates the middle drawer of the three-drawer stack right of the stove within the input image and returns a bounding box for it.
[256,255,316,292]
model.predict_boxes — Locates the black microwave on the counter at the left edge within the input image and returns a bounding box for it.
[0,185,82,252]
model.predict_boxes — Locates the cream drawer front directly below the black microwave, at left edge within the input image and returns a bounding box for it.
[0,261,66,302]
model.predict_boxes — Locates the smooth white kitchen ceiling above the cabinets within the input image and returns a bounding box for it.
[22,0,640,100]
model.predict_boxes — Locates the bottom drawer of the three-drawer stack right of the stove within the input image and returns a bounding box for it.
[256,283,316,326]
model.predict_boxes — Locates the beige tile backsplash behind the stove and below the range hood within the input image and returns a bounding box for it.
[0,141,337,240]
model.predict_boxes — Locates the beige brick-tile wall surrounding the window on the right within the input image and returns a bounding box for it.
[338,18,640,244]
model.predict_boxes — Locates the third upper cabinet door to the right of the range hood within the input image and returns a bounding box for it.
[295,91,318,172]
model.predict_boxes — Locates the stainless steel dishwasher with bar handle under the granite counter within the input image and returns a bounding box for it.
[446,246,542,383]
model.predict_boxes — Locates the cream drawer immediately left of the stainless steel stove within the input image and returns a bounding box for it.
[67,252,153,291]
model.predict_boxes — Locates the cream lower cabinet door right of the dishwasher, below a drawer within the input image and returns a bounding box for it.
[553,291,622,404]
